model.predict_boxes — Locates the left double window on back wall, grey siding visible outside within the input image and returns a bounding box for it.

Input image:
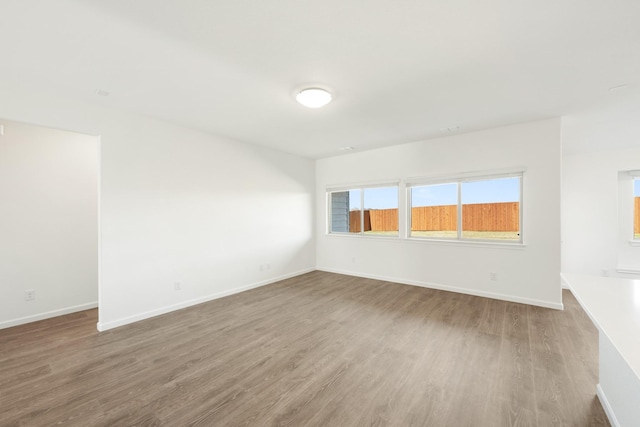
[328,185,398,236]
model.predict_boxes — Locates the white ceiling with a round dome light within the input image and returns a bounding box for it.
[0,0,640,158]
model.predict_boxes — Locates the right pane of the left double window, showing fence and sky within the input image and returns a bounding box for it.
[364,187,398,236]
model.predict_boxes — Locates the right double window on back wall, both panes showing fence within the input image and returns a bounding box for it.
[408,173,522,242]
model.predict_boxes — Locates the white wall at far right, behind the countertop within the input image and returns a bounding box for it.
[562,112,640,278]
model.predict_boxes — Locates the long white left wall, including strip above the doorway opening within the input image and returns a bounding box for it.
[0,83,315,329]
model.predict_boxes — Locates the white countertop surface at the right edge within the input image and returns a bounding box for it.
[561,273,640,379]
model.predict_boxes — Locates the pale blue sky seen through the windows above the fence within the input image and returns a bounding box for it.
[349,178,520,210]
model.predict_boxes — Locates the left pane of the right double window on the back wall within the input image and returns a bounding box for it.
[411,183,458,238]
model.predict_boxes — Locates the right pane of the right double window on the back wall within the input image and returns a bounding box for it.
[461,177,520,240]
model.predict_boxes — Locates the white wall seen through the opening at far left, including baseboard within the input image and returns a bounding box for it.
[0,119,98,328]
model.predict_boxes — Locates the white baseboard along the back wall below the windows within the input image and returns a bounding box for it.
[316,267,564,310]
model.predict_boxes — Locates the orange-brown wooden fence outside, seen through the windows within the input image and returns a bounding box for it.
[349,202,520,233]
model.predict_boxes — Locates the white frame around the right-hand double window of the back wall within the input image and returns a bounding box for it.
[405,169,525,246]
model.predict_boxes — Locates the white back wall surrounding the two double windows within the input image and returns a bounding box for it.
[316,119,562,308]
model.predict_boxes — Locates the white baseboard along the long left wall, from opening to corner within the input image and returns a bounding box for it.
[97,268,315,331]
